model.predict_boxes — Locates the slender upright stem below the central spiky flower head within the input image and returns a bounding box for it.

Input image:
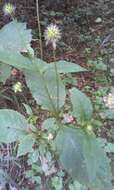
[53,49,59,112]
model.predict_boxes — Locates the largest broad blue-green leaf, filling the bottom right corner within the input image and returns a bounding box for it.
[56,127,112,190]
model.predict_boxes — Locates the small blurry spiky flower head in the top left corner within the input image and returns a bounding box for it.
[3,3,15,15]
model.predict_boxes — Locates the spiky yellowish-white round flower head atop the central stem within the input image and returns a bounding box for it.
[44,24,61,49]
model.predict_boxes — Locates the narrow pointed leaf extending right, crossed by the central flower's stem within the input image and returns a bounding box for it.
[47,60,87,73]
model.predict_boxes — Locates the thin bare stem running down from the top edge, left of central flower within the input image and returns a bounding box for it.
[36,0,43,59]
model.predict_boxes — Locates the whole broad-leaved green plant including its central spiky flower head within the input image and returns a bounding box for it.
[0,1,112,190]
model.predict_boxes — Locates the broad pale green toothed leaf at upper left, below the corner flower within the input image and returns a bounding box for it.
[0,20,32,52]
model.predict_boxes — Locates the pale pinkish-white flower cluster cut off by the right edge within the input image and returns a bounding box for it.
[103,93,114,109]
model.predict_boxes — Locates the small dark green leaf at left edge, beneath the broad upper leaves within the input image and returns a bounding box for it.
[0,63,11,83]
